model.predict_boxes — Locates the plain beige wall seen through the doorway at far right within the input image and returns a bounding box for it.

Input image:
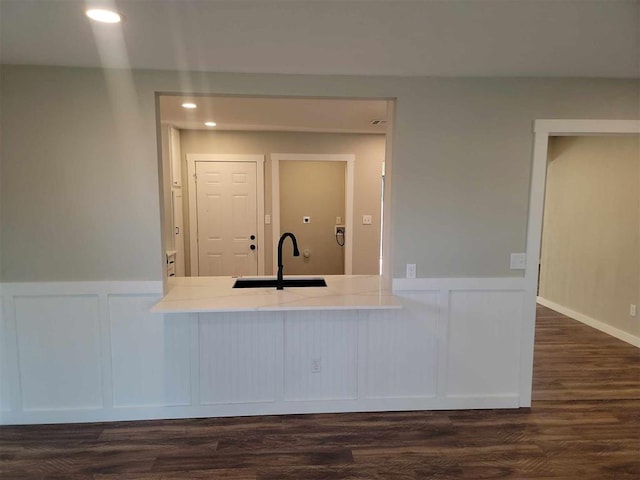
[539,136,640,338]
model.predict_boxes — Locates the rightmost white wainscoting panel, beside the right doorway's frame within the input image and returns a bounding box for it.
[447,291,523,396]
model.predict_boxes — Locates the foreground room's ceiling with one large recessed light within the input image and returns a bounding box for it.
[0,0,640,78]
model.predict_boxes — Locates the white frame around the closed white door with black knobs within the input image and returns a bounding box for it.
[187,153,265,277]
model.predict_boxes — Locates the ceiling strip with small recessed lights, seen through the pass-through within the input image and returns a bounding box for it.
[160,95,387,134]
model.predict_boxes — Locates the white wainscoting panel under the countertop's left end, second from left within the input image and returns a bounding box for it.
[108,295,191,407]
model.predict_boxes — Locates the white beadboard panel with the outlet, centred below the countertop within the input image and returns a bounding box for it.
[284,310,358,401]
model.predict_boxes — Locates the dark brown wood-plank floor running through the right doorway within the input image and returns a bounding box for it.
[0,307,640,480]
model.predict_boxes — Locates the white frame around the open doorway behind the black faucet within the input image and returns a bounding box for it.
[271,153,356,275]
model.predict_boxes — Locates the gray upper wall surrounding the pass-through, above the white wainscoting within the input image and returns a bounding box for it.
[0,66,640,281]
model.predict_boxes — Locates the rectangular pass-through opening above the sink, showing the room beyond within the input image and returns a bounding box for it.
[157,93,394,276]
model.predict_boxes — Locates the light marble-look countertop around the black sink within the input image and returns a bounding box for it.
[151,275,402,313]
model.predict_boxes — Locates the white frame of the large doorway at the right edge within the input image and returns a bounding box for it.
[520,120,640,406]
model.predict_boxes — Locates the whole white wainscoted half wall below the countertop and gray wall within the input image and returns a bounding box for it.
[0,278,534,424]
